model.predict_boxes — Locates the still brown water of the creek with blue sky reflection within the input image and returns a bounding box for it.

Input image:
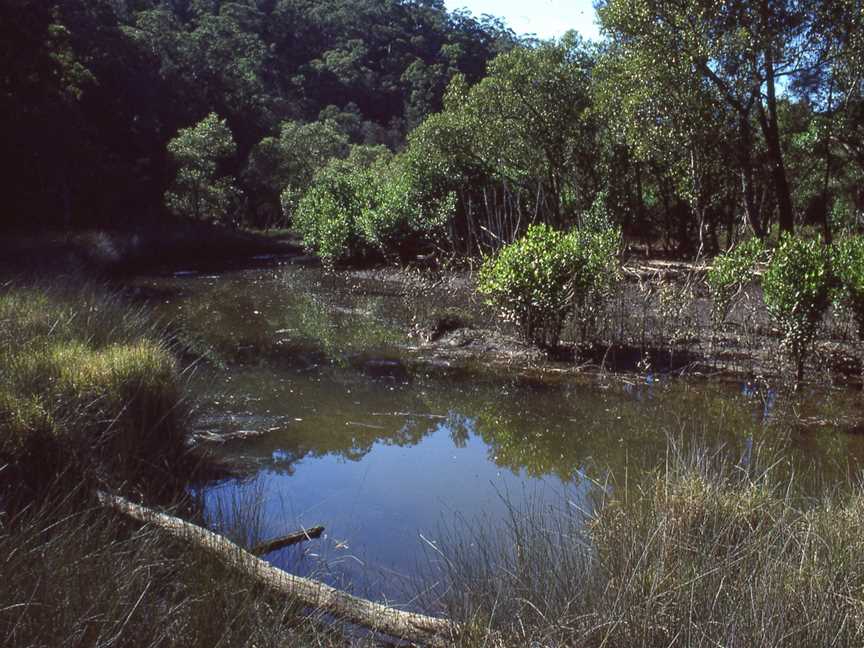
[138,266,864,607]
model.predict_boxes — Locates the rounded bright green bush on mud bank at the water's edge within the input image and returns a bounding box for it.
[478,224,620,347]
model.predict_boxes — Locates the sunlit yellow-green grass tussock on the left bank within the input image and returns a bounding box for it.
[0,286,185,498]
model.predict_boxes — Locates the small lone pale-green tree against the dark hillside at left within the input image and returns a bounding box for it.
[165,113,242,222]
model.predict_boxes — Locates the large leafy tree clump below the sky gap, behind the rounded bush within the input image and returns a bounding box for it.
[407,36,603,250]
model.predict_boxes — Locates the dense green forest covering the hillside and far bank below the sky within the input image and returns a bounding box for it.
[0,0,864,257]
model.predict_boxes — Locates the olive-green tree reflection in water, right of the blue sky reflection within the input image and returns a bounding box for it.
[452,384,844,481]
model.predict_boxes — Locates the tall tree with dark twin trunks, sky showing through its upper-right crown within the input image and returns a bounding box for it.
[599,0,852,235]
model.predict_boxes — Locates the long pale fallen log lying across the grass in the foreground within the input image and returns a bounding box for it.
[98,492,457,644]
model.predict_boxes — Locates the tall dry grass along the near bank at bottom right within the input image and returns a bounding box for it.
[447,442,864,648]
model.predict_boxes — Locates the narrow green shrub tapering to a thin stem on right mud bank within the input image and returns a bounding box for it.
[762,235,832,380]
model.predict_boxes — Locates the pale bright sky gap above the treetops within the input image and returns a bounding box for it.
[446,0,598,39]
